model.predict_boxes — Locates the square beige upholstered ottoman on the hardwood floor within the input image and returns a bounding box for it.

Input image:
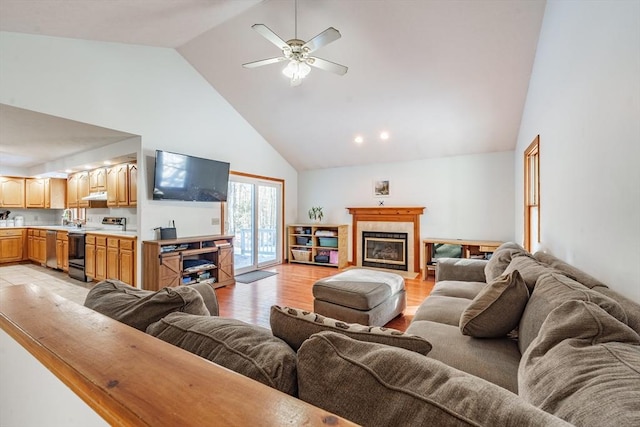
[313,268,407,326]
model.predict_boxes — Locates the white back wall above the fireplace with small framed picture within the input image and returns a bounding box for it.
[298,151,514,256]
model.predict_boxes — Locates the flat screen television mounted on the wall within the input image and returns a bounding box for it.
[153,150,229,202]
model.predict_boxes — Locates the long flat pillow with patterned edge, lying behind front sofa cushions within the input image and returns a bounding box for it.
[269,305,431,355]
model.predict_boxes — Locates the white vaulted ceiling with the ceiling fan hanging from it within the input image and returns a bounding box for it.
[0,0,545,170]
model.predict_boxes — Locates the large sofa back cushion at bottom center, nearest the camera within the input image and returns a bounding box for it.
[298,332,566,426]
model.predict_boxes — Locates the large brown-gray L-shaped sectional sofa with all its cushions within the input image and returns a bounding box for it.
[85,243,640,427]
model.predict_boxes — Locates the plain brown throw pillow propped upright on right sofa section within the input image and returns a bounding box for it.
[460,270,529,338]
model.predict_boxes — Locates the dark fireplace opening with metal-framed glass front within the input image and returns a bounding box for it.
[362,231,408,271]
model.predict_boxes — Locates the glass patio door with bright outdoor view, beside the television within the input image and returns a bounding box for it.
[225,173,283,274]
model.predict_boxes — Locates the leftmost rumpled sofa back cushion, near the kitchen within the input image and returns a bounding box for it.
[84,279,210,331]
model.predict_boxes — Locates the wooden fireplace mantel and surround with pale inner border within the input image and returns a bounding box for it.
[347,207,424,274]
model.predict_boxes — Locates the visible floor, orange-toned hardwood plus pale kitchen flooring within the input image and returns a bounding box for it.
[0,264,434,331]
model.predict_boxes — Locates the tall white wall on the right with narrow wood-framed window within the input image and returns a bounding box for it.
[514,0,640,301]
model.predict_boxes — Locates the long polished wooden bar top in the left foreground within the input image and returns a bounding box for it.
[0,285,355,426]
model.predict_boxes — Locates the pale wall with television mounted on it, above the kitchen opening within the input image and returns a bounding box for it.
[0,32,297,244]
